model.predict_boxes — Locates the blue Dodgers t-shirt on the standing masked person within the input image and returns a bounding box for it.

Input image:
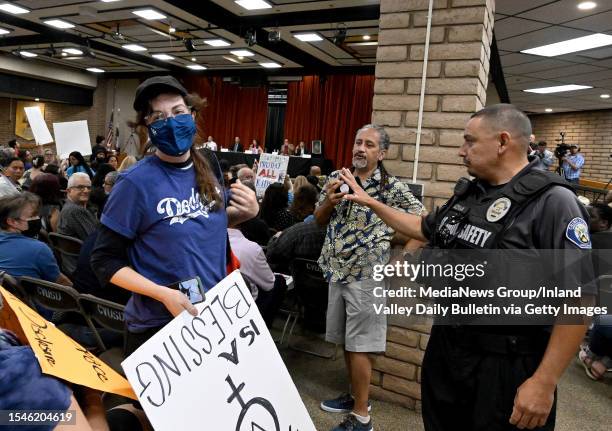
[101,156,227,332]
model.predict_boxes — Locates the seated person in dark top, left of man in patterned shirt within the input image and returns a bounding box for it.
[266,222,326,273]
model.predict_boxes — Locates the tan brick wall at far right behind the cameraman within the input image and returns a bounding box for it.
[530,109,612,182]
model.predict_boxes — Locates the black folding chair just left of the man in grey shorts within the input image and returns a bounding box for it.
[288,258,338,360]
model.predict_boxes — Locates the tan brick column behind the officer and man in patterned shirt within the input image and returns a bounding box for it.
[371,0,494,409]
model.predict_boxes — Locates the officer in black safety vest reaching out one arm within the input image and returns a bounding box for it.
[342,104,591,431]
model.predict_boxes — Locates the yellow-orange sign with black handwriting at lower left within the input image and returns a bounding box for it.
[0,287,136,399]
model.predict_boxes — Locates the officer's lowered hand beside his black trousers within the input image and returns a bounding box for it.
[510,377,555,429]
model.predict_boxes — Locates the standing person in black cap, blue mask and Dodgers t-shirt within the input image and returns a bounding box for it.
[91,76,259,354]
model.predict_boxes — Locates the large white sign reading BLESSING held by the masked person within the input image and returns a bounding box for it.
[121,271,316,431]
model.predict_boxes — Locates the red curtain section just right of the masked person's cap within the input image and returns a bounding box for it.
[184,76,268,148]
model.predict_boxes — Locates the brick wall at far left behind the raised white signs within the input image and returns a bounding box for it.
[0,79,107,153]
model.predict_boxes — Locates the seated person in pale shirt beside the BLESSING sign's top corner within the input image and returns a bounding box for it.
[227,227,287,327]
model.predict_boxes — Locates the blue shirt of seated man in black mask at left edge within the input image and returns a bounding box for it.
[0,232,60,282]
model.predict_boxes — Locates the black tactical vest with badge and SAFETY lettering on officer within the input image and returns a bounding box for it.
[430,163,575,249]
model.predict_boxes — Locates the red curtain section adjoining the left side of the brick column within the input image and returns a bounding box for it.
[285,75,375,168]
